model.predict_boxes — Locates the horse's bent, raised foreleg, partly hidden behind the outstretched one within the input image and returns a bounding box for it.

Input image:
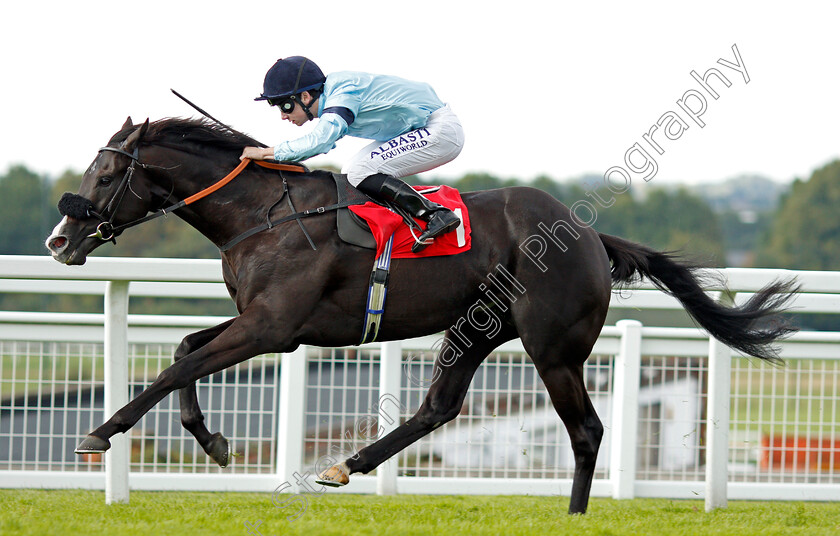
[175,319,233,467]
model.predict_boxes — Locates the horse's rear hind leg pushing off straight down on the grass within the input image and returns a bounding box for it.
[523,324,604,514]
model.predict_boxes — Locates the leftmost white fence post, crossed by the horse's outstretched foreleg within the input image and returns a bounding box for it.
[104,281,131,504]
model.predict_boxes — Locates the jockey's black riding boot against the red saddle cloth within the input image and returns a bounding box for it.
[357,173,461,253]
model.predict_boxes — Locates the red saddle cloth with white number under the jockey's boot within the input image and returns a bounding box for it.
[349,186,471,259]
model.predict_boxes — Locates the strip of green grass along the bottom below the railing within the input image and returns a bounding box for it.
[0,490,840,536]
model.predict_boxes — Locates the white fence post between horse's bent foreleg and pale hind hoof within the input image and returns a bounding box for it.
[277,346,308,493]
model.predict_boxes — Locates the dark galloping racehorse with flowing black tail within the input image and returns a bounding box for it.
[46,119,796,513]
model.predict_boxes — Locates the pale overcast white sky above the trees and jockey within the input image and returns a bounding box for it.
[0,0,840,185]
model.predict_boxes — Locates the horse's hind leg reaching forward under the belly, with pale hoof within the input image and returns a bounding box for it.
[318,324,515,486]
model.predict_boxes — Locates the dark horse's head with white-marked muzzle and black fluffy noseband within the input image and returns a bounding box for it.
[46,117,158,264]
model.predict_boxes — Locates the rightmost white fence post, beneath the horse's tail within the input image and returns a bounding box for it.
[706,337,732,512]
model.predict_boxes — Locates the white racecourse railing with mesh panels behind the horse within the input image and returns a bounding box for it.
[0,256,840,509]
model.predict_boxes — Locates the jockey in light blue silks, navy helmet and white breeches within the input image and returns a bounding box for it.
[240,56,464,253]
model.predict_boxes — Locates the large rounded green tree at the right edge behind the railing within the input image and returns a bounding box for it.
[757,160,840,270]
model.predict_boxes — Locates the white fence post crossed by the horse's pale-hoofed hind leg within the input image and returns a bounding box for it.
[376,341,402,495]
